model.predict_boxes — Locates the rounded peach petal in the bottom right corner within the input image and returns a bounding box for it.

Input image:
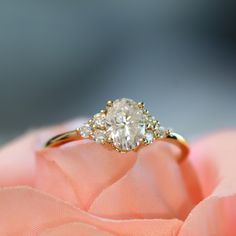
[179,195,236,236]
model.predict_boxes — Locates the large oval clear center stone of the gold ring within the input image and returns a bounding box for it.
[106,98,146,151]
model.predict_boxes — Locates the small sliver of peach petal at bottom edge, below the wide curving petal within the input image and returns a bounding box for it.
[39,222,112,236]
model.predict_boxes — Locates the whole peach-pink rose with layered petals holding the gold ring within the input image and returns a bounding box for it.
[0,120,236,236]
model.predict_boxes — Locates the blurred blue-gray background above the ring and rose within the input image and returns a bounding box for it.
[0,0,236,144]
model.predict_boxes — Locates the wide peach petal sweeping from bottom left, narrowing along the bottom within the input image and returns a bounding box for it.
[0,187,182,236]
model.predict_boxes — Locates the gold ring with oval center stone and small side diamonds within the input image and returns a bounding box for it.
[45,98,189,161]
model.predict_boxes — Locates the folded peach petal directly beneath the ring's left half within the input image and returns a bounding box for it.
[35,140,136,209]
